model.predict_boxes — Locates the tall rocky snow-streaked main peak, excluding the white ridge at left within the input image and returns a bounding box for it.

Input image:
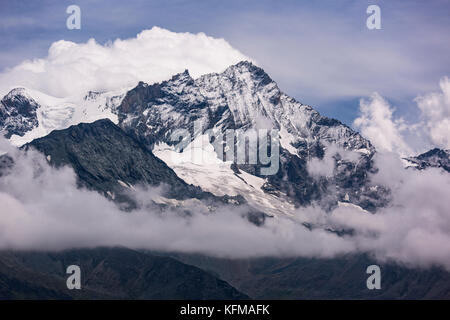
[117,61,387,213]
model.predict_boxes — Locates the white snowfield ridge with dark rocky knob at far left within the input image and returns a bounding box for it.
[0,87,126,146]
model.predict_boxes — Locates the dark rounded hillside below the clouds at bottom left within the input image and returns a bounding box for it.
[0,248,248,300]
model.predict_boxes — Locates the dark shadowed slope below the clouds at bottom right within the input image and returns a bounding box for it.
[166,253,450,300]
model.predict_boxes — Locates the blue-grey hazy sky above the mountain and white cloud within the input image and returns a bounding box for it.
[0,0,450,124]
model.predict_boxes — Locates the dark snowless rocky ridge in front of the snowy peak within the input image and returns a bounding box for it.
[25,119,225,206]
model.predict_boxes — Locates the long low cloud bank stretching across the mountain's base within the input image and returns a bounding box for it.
[0,139,450,271]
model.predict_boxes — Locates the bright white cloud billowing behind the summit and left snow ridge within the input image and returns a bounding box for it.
[0,27,250,97]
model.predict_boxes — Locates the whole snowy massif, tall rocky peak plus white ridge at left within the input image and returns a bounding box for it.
[0,61,388,215]
